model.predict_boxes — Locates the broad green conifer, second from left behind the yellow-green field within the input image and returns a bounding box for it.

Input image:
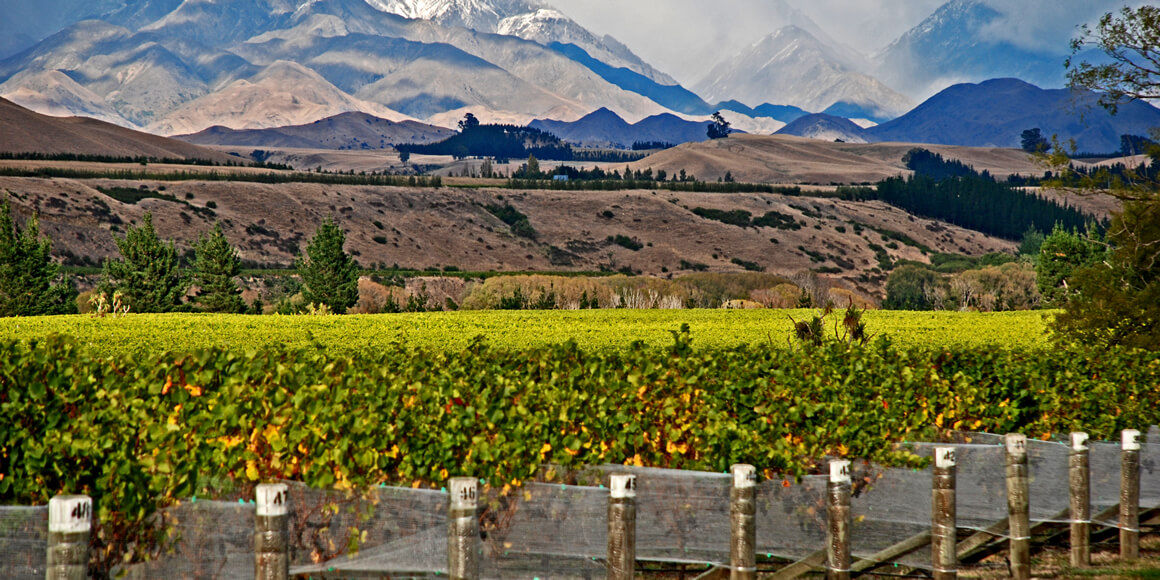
[97,212,189,312]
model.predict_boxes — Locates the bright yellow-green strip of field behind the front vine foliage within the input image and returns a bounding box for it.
[0,310,1052,356]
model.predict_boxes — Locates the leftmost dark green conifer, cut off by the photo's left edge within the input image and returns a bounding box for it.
[0,198,77,317]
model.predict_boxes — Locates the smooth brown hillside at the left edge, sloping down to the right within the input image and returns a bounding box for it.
[0,99,238,164]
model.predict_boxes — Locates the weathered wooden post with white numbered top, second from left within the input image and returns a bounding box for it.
[254,484,290,580]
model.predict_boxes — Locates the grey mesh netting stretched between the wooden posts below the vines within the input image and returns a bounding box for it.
[0,427,1160,580]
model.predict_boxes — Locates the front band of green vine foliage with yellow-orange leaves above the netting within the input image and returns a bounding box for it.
[0,331,1160,574]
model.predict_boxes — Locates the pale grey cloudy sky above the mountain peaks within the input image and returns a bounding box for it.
[549,0,1144,86]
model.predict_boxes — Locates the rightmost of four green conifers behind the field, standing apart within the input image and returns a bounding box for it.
[296,218,358,314]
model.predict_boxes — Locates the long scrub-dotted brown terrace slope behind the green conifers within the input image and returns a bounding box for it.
[0,172,1015,297]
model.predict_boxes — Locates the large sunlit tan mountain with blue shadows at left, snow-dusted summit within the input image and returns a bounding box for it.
[0,0,670,132]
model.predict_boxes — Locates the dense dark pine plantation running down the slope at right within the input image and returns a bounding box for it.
[839,150,1096,240]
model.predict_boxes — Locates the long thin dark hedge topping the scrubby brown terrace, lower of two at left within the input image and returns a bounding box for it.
[0,167,443,188]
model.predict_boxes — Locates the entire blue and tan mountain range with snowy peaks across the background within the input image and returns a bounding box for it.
[0,0,1147,148]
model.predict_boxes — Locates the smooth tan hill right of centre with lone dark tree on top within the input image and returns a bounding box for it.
[631,135,1044,186]
